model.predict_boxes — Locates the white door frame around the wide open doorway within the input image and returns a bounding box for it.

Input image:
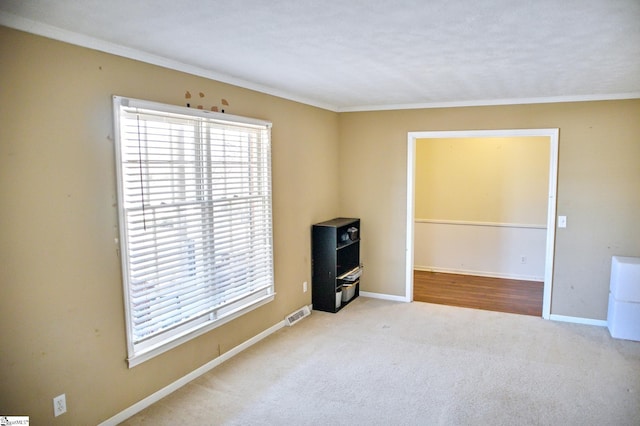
[405,128,559,319]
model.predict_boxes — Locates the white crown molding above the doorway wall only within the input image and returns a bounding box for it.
[336,92,640,112]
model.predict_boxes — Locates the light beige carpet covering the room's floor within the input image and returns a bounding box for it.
[125,297,640,425]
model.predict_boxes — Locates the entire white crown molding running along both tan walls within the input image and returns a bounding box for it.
[0,11,640,112]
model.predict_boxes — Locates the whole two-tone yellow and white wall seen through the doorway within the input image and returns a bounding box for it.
[414,136,550,281]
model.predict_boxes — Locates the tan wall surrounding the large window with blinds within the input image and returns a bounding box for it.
[0,27,338,425]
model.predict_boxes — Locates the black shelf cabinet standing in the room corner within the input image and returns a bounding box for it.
[311,217,362,313]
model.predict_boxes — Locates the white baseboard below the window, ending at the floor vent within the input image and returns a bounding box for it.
[100,320,285,426]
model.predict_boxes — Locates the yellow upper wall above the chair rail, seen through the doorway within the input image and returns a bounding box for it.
[415,136,550,225]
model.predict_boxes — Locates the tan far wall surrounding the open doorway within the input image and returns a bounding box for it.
[340,100,640,320]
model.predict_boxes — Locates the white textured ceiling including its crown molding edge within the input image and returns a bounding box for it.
[0,0,640,111]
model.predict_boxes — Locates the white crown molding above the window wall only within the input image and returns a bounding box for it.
[0,11,337,112]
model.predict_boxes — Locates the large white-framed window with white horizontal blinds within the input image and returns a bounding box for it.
[113,96,274,367]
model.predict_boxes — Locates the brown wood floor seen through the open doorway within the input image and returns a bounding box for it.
[413,271,544,317]
